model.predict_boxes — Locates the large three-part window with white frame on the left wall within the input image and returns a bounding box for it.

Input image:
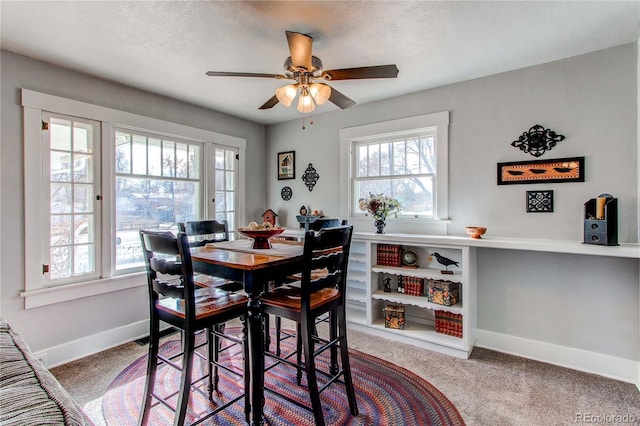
[21,89,246,309]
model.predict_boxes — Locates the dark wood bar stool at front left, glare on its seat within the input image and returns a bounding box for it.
[139,230,251,426]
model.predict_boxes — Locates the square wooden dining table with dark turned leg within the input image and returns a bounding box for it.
[191,239,303,425]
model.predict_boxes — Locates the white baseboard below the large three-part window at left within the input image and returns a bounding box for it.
[34,320,149,368]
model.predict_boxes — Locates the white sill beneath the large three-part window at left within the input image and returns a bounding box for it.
[20,272,146,309]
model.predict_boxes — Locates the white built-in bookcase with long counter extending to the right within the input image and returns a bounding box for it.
[283,229,640,358]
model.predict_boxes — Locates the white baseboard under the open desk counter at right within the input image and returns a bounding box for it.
[475,329,640,390]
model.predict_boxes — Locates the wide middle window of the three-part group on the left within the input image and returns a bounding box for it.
[114,128,203,271]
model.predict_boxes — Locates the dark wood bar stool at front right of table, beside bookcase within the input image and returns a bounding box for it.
[262,226,358,425]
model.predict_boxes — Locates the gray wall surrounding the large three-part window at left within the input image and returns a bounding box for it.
[0,51,265,351]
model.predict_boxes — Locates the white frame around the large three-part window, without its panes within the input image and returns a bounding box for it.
[20,89,246,309]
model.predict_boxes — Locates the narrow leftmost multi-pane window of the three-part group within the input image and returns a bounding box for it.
[42,113,100,285]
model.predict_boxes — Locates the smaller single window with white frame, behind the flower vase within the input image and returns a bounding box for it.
[340,112,449,225]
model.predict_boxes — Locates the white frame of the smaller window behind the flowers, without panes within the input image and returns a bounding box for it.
[340,111,449,228]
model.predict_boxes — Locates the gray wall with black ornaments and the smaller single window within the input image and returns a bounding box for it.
[266,43,640,360]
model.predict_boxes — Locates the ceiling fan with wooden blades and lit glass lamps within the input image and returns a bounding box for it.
[206,31,398,113]
